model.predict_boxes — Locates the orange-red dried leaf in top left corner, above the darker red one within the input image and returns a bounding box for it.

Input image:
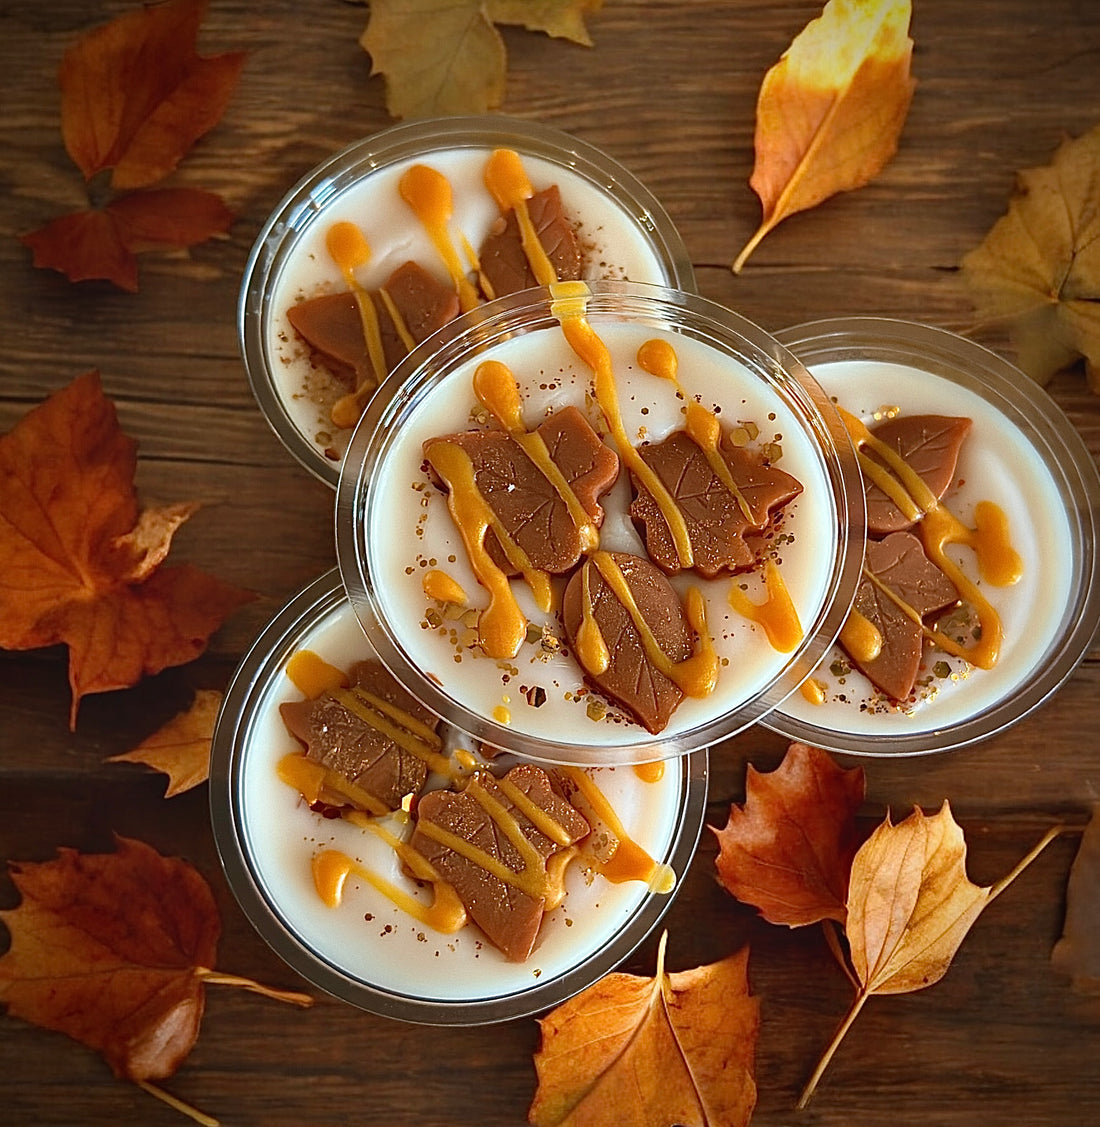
[57,0,245,188]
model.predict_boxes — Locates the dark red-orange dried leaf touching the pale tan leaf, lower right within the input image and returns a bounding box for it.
[710,744,866,928]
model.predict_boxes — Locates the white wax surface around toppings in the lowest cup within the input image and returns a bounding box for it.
[240,603,685,1001]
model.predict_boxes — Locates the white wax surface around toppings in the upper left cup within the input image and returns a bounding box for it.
[265,147,671,471]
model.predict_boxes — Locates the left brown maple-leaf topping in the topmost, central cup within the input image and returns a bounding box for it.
[425,406,619,575]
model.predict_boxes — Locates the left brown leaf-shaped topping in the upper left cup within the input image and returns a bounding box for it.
[286,261,459,388]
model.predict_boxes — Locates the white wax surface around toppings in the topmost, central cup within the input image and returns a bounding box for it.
[364,320,837,747]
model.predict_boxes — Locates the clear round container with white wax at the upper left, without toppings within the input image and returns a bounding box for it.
[237,115,694,486]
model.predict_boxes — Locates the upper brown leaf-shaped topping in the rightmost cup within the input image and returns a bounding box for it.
[863,415,970,536]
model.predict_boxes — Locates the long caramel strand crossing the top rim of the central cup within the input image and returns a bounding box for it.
[550,282,694,568]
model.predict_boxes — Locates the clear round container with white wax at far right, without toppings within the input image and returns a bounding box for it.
[765,317,1100,755]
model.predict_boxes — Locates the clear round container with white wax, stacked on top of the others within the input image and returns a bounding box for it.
[336,282,864,765]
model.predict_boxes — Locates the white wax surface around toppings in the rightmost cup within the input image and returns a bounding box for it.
[779,361,1073,737]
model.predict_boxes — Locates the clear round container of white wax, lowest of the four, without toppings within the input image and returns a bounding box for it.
[210,570,707,1024]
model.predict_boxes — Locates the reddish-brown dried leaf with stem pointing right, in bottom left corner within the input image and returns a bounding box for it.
[0,837,312,1082]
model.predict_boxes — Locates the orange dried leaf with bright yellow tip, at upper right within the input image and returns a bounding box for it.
[733,0,915,273]
